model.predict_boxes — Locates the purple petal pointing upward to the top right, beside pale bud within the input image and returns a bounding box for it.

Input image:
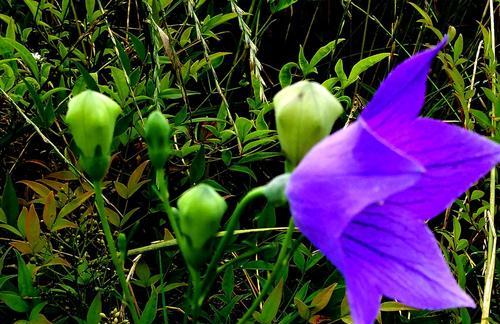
[361,37,447,137]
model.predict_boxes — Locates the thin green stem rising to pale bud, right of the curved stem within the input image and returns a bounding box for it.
[238,217,295,324]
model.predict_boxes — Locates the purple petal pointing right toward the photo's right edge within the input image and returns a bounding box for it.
[376,118,500,220]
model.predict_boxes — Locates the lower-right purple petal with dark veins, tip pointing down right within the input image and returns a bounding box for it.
[337,204,474,323]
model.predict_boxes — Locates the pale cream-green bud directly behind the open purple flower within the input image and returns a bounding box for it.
[273,81,342,167]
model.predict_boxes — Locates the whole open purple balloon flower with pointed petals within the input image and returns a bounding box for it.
[287,39,500,324]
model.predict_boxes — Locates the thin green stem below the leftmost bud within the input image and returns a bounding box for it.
[94,181,139,323]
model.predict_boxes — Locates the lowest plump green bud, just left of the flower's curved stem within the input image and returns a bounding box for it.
[177,184,227,268]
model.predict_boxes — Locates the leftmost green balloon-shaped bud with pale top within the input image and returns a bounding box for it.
[66,90,121,180]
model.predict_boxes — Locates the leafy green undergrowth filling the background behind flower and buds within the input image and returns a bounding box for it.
[0,0,500,323]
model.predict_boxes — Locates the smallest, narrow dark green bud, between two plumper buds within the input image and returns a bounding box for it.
[144,110,172,169]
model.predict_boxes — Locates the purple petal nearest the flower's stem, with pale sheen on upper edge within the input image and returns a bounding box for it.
[287,122,424,244]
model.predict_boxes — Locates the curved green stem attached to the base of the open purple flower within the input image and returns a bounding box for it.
[196,186,264,308]
